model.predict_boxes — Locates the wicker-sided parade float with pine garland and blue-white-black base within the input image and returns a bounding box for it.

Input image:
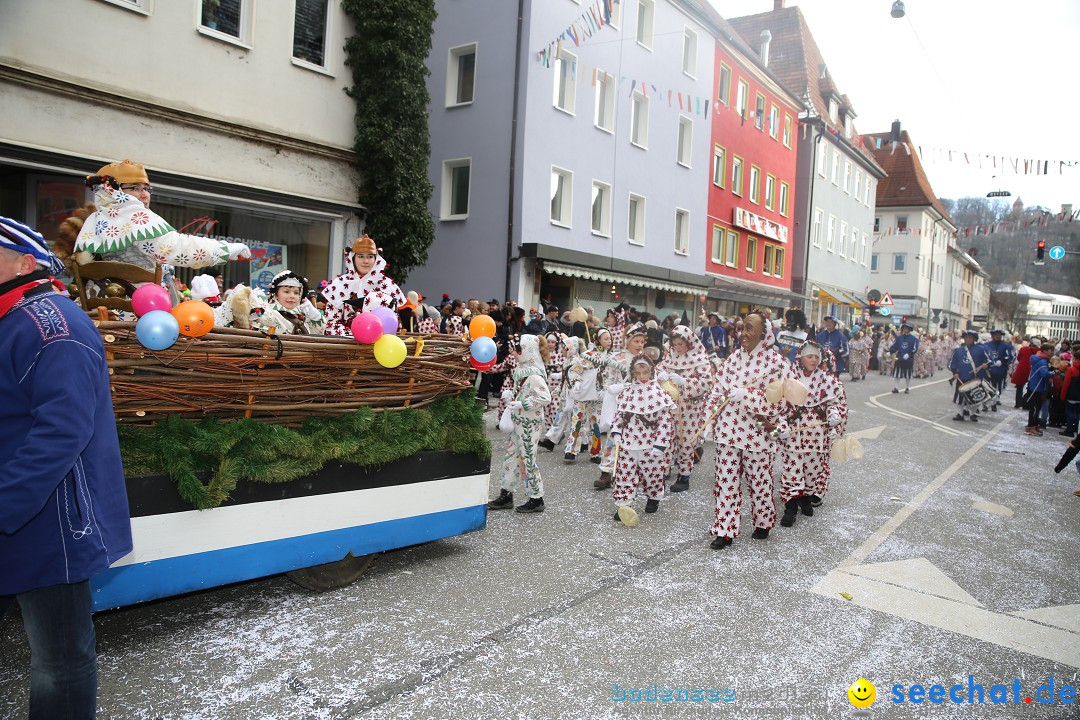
[83,286,490,610]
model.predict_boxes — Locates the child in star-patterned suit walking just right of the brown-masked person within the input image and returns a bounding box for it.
[778,340,848,528]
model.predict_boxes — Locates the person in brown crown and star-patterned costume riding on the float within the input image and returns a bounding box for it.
[323,235,405,338]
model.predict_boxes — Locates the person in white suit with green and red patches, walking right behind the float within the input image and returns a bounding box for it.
[487,335,551,513]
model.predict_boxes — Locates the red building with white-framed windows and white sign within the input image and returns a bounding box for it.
[705,21,805,313]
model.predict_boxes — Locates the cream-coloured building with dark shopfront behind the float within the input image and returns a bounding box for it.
[0,0,361,284]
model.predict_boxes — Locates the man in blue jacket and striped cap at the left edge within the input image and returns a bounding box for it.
[0,218,132,720]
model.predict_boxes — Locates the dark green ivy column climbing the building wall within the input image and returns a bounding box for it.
[342,0,435,283]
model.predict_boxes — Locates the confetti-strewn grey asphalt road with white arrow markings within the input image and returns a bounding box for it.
[0,373,1080,720]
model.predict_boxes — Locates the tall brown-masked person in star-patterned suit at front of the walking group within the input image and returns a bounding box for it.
[704,311,805,549]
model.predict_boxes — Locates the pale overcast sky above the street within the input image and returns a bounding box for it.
[712,0,1080,212]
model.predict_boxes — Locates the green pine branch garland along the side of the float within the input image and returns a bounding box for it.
[117,391,491,510]
